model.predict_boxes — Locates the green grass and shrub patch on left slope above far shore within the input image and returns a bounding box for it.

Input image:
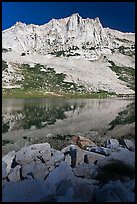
[2,62,119,98]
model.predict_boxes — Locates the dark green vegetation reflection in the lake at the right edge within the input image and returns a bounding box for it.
[109,102,135,130]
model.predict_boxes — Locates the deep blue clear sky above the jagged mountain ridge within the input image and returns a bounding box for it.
[2,2,135,32]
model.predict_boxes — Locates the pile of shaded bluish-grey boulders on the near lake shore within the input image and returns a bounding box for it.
[2,136,135,202]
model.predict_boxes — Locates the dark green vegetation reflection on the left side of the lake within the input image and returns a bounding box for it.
[2,104,77,132]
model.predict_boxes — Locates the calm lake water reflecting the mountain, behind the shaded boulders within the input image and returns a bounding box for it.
[2,98,135,153]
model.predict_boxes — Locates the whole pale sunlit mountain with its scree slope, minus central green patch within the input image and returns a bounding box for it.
[2,13,135,94]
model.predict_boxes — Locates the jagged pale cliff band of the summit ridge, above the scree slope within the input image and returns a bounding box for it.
[2,13,135,56]
